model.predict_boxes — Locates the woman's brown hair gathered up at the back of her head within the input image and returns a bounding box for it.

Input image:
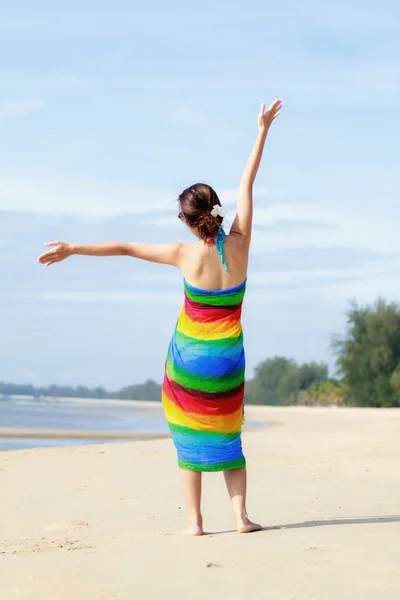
[178,183,222,241]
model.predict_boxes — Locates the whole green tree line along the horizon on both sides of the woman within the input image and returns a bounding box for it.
[0,299,400,407]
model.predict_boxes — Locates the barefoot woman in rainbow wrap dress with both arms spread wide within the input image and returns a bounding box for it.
[38,100,282,536]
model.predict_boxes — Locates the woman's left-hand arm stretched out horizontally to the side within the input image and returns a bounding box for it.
[37,242,187,267]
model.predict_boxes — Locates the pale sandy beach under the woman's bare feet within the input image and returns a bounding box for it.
[0,407,400,600]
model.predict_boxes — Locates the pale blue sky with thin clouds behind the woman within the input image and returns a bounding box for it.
[0,0,400,389]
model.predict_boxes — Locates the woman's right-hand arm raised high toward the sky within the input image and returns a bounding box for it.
[230,100,282,243]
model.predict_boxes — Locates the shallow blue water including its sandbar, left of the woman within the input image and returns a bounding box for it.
[0,396,169,452]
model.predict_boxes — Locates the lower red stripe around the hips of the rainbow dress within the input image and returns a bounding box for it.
[163,375,244,416]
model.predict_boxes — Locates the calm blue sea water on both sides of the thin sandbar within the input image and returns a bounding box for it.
[0,399,168,451]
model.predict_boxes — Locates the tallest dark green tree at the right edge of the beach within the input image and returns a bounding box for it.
[333,299,400,407]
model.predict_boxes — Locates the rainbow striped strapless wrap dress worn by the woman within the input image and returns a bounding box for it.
[162,281,246,471]
